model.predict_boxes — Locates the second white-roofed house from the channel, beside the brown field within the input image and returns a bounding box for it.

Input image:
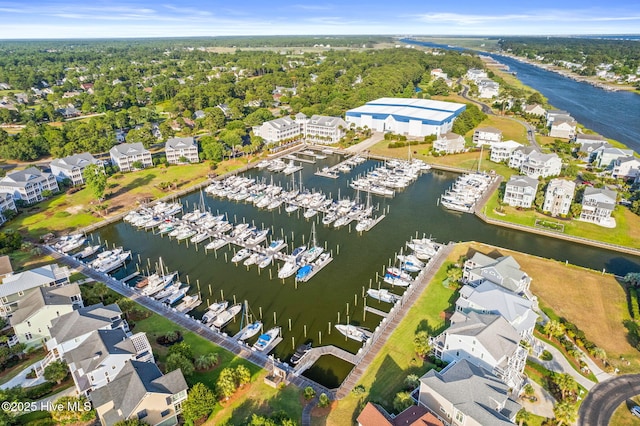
[456,281,538,343]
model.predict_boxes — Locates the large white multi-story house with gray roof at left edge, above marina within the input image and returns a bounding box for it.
[0,167,59,204]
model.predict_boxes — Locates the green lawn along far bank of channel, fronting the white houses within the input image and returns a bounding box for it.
[484,191,640,248]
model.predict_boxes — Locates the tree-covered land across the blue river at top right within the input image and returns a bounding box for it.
[498,37,640,76]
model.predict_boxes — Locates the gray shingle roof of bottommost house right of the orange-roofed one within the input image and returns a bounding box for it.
[420,360,521,426]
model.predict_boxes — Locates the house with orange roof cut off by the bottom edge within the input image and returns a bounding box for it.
[356,402,444,426]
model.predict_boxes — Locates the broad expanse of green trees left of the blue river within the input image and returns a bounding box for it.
[0,37,482,161]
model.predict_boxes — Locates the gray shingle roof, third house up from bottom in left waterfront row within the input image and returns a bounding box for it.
[49,303,122,343]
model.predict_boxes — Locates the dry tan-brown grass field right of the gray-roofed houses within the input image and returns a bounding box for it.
[464,243,640,373]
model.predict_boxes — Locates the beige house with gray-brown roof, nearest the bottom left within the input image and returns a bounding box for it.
[89,361,188,426]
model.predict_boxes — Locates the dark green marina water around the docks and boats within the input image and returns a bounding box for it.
[94,156,640,385]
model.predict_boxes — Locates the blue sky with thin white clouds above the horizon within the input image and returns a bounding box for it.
[0,0,640,39]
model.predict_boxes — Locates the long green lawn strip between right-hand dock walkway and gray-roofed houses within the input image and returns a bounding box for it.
[324,251,461,425]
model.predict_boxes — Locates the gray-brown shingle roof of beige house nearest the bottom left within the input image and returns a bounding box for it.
[89,361,187,424]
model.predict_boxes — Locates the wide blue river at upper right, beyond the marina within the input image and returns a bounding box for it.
[402,39,640,153]
